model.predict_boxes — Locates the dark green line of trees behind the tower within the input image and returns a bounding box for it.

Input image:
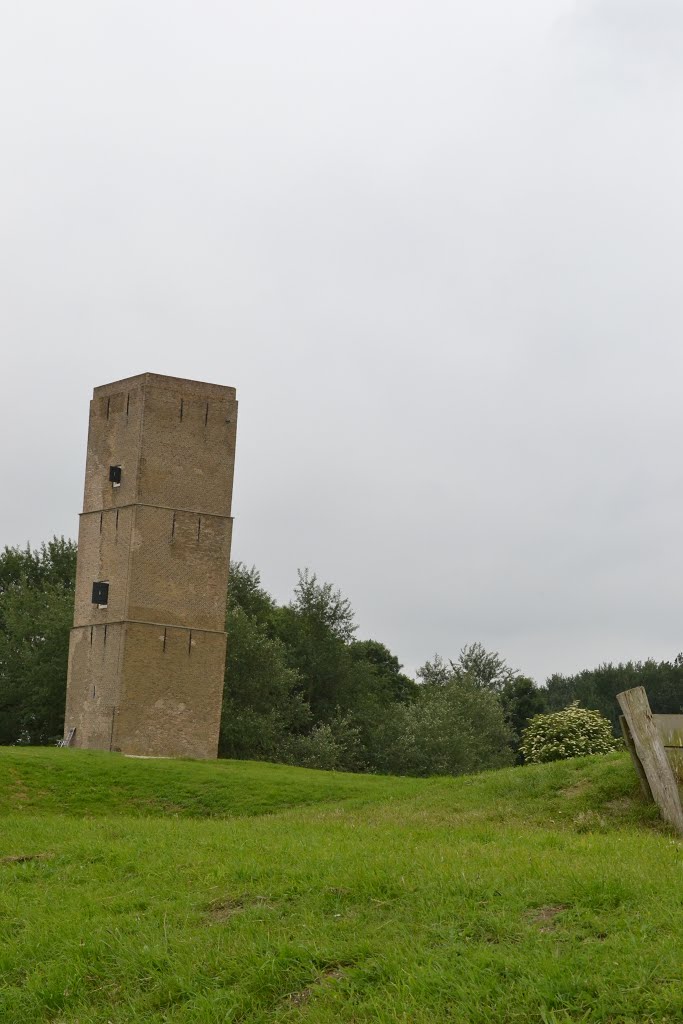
[0,538,683,775]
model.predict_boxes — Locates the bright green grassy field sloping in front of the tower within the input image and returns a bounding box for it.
[0,749,683,1024]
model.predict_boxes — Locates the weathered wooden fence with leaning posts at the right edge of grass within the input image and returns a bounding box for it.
[616,686,683,835]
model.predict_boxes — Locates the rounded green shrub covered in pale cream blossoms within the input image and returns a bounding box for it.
[520,700,617,764]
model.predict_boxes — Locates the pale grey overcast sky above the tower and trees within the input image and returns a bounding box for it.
[0,0,683,680]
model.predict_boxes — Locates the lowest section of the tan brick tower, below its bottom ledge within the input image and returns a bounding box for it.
[65,621,226,758]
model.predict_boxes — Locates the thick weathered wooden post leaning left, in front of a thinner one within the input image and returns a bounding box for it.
[616,686,683,835]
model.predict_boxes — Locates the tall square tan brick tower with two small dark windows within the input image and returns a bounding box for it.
[63,374,238,758]
